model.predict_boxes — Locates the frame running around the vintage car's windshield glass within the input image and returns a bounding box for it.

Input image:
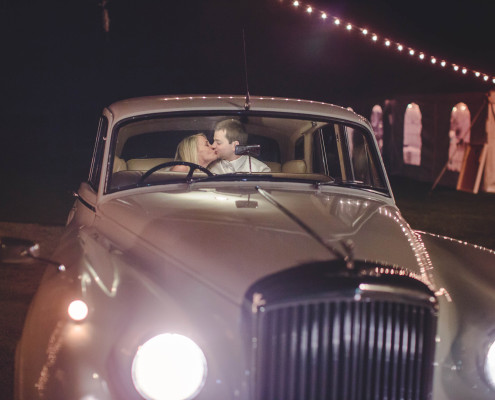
[104,109,391,196]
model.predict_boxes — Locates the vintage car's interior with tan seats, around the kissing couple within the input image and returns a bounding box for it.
[105,115,384,191]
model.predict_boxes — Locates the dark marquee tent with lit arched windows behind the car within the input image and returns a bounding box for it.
[351,92,495,192]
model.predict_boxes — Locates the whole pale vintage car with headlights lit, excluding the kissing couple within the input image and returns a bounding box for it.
[1,96,495,400]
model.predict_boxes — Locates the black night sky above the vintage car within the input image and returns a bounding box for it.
[0,0,495,197]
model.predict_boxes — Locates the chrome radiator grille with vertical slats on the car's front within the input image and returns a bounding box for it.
[253,297,436,400]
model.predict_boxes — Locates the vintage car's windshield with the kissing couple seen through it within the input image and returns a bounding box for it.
[107,113,387,192]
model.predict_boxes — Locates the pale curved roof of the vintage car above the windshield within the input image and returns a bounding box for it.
[107,95,370,127]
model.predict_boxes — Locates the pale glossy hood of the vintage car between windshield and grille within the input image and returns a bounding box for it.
[98,185,431,303]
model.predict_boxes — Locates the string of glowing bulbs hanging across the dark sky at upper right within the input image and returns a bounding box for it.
[279,0,495,84]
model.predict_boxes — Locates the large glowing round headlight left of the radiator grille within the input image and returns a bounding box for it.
[132,333,206,400]
